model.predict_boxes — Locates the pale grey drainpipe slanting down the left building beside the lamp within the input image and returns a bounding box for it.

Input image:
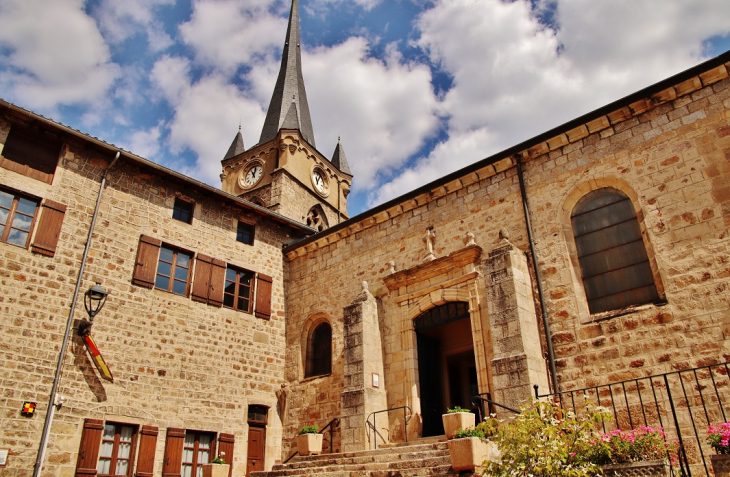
[33,151,121,477]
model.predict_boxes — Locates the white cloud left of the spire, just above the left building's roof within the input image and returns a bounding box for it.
[149,56,264,184]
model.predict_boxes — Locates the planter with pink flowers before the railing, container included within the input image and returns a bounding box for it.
[591,426,677,477]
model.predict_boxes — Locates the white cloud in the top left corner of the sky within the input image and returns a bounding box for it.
[0,0,120,109]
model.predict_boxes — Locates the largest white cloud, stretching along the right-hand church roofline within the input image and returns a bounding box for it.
[369,0,730,205]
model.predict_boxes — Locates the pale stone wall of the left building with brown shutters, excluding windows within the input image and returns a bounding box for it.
[0,120,292,476]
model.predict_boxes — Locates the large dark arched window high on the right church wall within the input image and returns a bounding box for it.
[571,187,659,314]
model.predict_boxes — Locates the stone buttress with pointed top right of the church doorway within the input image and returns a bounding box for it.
[485,238,548,409]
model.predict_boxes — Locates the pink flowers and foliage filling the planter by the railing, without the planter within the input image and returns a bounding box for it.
[590,426,677,465]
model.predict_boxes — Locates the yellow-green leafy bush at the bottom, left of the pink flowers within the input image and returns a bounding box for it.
[486,401,606,477]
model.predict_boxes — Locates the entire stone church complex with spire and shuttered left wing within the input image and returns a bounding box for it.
[0,0,730,477]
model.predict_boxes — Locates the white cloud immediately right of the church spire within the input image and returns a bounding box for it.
[302,38,438,190]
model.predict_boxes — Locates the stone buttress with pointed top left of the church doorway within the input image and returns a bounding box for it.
[340,282,388,452]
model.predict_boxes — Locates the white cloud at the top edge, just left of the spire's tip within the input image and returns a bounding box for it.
[180,0,287,73]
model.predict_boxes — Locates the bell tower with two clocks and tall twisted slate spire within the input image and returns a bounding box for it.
[221,0,353,231]
